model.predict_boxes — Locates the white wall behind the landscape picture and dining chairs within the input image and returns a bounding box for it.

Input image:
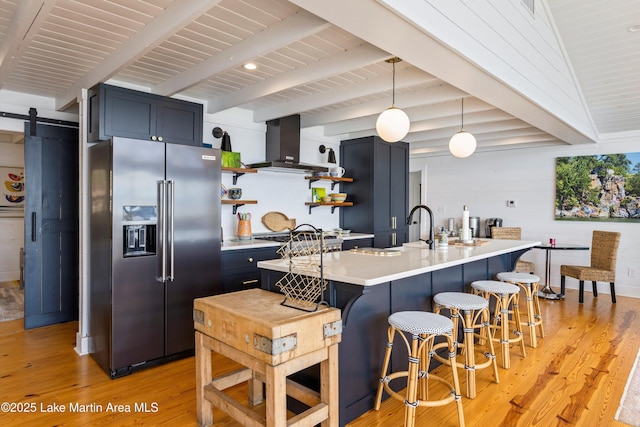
[410,138,640,298]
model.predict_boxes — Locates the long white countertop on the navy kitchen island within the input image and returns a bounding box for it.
[258,239,540,286]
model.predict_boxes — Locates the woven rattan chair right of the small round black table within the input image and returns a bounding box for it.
[560,230,620,304]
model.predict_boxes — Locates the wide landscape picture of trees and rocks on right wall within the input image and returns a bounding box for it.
[555,153,640,222]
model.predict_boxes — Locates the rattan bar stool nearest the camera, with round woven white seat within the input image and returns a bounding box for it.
[375,311,464,427]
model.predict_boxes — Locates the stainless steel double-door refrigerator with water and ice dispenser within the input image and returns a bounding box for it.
[89,138,221,378]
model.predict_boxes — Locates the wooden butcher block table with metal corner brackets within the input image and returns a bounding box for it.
[193,289,342,427]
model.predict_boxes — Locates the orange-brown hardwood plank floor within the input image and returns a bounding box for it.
[0,291,640,427]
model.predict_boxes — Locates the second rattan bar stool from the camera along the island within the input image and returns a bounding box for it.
[433,292,500,399]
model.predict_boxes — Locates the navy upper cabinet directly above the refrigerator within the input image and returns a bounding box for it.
[88,84,203,146]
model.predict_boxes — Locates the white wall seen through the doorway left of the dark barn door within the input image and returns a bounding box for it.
[0,144,24,282]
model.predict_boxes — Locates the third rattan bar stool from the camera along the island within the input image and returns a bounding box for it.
[471,280,527,369]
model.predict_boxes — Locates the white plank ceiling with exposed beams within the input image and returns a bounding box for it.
[0,0,640,156]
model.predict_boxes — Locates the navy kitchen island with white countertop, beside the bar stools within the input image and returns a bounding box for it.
[258,240,540,426]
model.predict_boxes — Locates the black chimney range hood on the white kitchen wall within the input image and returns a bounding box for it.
[248,114,329,173]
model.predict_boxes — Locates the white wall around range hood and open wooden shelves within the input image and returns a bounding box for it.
[204,109,348,240]
